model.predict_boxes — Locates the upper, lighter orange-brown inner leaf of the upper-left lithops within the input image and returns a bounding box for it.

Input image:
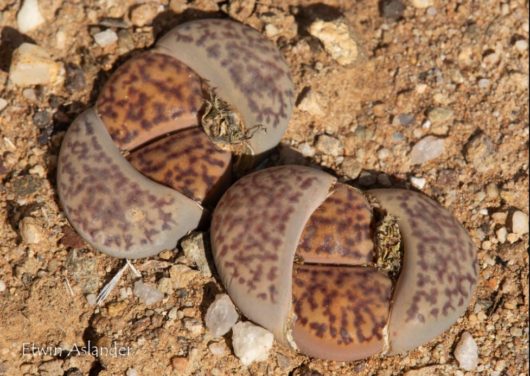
[96,51,203,150]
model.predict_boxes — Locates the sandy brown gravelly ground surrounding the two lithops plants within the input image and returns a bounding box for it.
[0,0,529,376]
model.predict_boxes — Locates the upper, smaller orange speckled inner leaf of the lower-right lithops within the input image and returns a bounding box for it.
[296,183,374,265]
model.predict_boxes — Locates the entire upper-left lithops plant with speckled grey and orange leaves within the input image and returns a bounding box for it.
[57,19,293,258]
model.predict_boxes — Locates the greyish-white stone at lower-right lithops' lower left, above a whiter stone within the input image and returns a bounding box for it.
[204,294,239,338]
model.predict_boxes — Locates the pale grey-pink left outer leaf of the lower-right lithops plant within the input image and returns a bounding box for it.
[211,166,335,339]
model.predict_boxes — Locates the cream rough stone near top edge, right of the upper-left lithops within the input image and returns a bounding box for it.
[309,20,359,65]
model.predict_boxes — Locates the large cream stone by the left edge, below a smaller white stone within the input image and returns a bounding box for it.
[9,43,64,86]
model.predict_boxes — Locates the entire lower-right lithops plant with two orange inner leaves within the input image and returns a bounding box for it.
[211,166,477,361]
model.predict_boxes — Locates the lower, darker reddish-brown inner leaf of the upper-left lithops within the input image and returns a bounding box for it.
[128,127,231,203]
